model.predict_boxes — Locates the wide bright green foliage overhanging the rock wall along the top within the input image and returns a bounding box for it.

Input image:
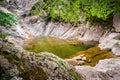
[30,0,120,25]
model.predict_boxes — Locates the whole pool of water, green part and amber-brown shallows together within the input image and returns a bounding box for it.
[24,37,114,66]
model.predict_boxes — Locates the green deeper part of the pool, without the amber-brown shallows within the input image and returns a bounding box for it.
[24,37,93,58]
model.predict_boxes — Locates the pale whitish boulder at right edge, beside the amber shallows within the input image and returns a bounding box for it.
[99,33,120,56]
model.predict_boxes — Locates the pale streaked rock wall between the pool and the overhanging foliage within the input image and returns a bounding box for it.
[23,17,104,41]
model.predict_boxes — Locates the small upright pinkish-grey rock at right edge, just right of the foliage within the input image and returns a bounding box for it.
[113,14,120,32]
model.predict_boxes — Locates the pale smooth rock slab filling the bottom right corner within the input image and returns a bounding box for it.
[76,58,120,80]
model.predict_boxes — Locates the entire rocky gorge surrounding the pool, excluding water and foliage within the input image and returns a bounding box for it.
[0,0,120,80]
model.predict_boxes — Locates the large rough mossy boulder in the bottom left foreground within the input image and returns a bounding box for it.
[0,40,80,80]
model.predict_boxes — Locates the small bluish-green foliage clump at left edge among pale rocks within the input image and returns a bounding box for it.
[0,10,19,28]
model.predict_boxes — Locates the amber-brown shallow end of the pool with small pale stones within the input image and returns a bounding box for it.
[67,46,115,66]
